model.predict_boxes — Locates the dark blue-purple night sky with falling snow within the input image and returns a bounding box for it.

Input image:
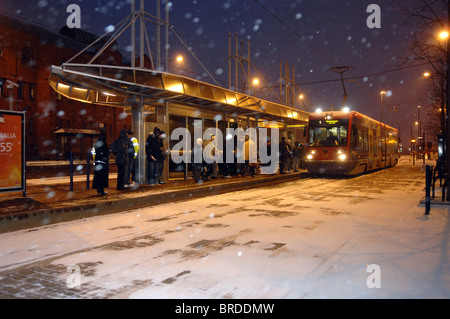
[0,0,431,146]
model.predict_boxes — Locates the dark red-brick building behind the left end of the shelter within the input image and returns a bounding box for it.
[0,15,131,161]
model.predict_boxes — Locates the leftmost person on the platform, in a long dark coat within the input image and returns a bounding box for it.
[92,132,109,196]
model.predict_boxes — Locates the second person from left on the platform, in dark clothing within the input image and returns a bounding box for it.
[111,130,133,190]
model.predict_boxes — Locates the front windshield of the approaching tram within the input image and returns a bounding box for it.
[308,119,349,147]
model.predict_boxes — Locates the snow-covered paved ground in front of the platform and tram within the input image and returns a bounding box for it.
[0,160,450,299]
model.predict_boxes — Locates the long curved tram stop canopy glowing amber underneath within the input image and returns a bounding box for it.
[49,63,309,125]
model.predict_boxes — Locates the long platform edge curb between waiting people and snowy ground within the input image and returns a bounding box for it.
[0,172,309,233]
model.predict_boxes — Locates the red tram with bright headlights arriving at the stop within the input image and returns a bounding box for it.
[305,111,399,175]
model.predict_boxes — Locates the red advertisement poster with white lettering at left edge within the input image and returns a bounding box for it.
[0,110,25,192]
